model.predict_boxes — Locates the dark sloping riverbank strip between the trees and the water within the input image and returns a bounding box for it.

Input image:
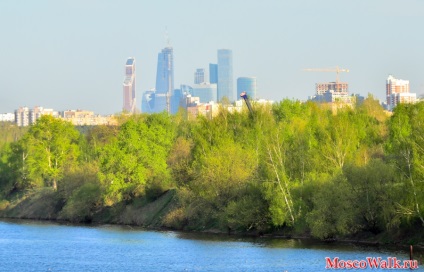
[0,190,424,250]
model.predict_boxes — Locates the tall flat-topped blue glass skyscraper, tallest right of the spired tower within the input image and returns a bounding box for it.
[218,49,234,102]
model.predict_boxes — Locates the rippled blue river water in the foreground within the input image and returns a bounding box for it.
[0,221,423,272]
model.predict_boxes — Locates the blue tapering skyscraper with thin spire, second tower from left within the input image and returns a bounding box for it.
[155,46,174,112]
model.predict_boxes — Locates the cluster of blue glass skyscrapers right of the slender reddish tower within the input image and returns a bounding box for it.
[141,45,264,114]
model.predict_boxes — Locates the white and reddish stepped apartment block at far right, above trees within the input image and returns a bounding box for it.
[386,75,417,111]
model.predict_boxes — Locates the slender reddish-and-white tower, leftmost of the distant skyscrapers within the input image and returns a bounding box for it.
[123,57,136,113]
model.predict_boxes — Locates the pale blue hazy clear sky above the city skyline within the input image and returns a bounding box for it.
[0,0,424,114]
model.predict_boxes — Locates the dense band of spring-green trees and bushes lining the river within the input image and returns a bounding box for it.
[0,99,424,239]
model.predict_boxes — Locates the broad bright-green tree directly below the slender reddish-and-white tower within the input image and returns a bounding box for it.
[99,113,175,205]
